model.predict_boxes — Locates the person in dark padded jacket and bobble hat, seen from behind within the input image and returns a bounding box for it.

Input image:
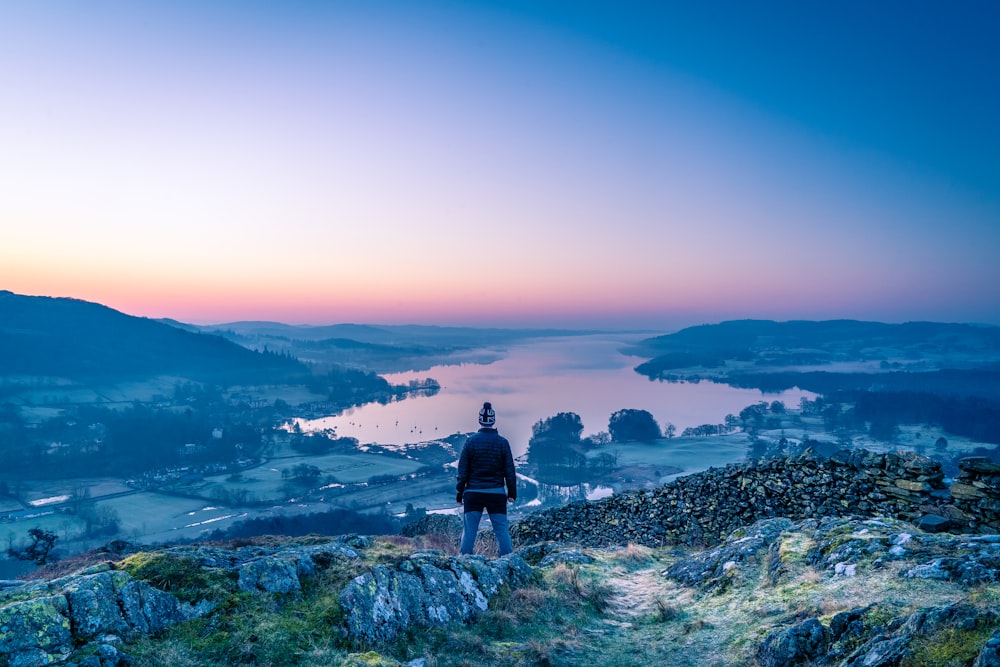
[456,402,517,556]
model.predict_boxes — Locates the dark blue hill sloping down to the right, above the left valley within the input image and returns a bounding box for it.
[0,290,307,382]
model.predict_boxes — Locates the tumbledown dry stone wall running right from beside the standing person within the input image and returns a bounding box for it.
[512,450,1000,546]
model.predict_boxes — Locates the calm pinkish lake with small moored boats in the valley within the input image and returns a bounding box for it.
[301,334,815,456]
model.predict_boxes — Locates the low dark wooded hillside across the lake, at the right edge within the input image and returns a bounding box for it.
[630,320,1000,400]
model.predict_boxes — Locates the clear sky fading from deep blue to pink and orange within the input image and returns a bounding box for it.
[0,0,1000,330]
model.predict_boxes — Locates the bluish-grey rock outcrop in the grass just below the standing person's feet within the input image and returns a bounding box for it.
[340,552,533,643]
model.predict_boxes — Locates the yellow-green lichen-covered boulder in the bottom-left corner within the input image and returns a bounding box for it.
[0,595,72,667]
